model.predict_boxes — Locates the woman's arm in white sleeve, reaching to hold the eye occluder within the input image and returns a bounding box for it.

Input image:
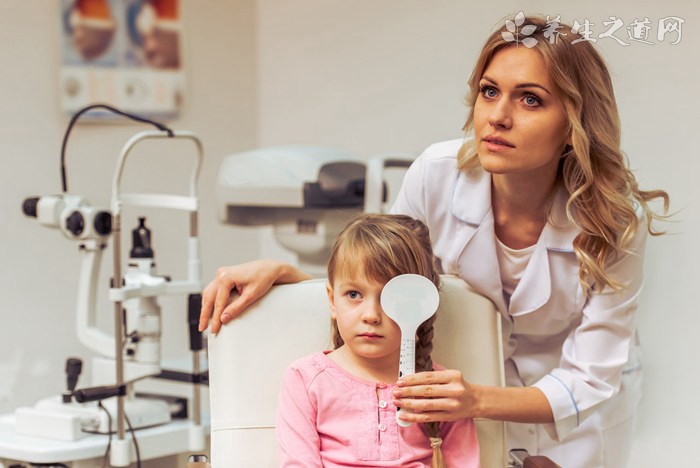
[396,223,646,439]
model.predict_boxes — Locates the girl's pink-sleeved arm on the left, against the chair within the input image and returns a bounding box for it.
[275,367,323,468]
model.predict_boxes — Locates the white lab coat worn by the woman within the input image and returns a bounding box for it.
[392,140,646,468]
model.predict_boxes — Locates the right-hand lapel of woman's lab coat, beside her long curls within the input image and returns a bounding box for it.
[509,188,580,316]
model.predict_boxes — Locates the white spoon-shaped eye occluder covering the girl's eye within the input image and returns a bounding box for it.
[380,274,440,427]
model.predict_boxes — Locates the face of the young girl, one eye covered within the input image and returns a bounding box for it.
[326,274,401,367]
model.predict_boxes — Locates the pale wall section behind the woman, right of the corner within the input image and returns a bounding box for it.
[258,0,700,467]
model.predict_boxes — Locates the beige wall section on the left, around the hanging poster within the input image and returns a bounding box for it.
[0,0,258,413]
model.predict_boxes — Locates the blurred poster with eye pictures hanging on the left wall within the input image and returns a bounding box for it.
[60,0,184,118]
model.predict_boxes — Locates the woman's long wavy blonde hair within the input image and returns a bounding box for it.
[457,16,669,290]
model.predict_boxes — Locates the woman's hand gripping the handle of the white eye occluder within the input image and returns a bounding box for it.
[393,370,477,423]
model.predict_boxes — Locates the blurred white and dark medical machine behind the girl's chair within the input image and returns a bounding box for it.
[217,145,415,276]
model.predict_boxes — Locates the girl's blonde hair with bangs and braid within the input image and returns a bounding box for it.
[328,214,446,468]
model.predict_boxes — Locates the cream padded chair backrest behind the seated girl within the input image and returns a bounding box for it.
[209,276,507,468]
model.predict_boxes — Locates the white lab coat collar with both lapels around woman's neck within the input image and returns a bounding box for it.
[450,166,580,316]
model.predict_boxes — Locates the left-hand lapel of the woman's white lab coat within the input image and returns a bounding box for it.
[451,171,506,311]
